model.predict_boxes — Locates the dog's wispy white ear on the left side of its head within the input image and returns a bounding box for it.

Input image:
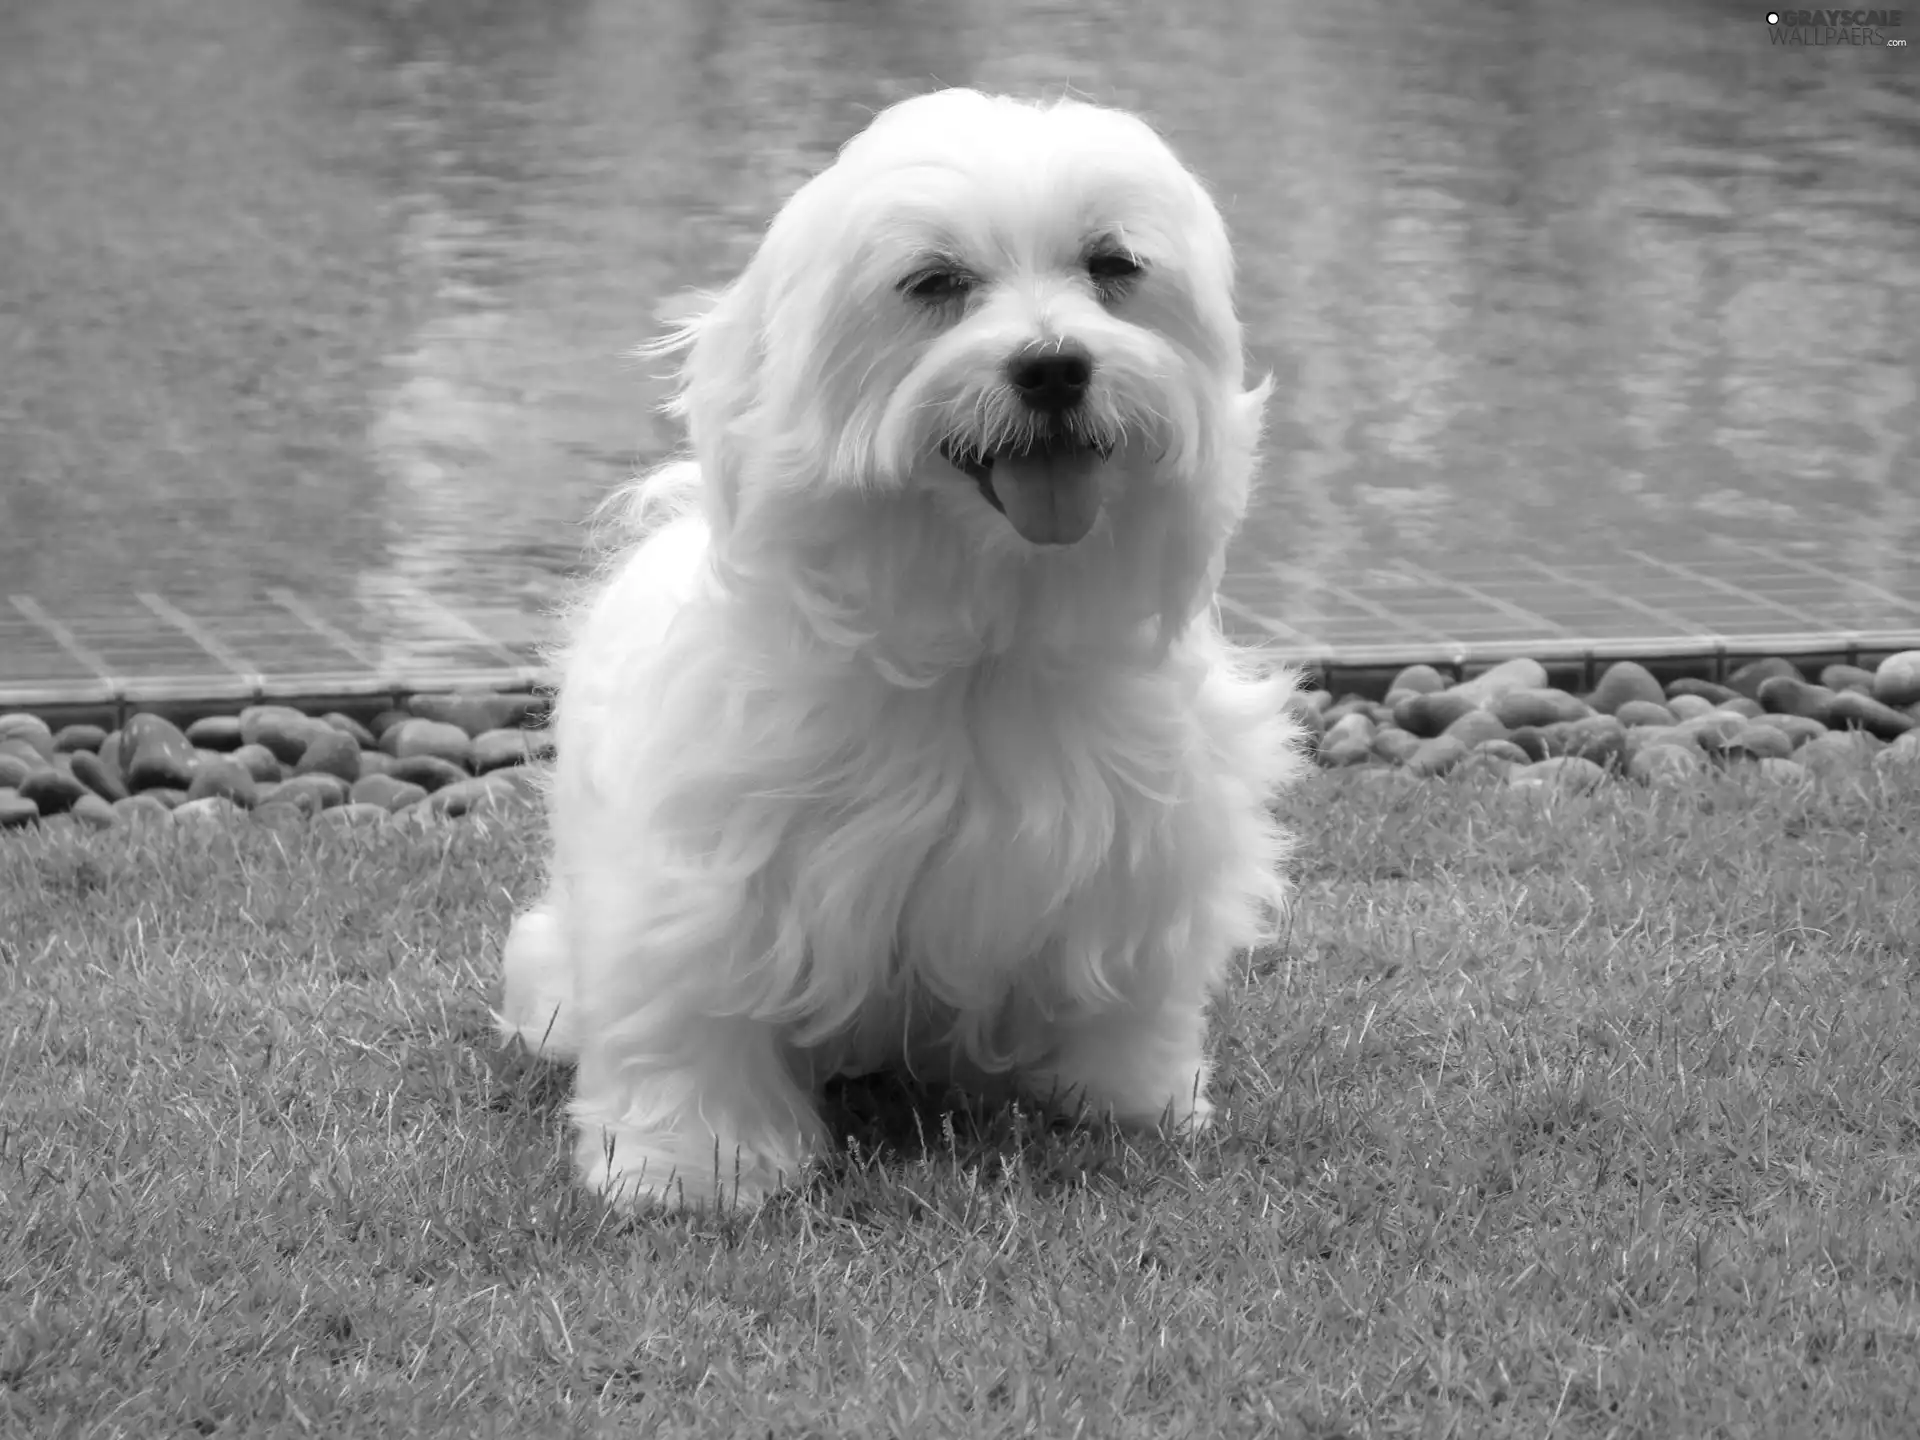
[643,278,766,534]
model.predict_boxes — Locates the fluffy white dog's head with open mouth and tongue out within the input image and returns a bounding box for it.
[652,90,1265,648]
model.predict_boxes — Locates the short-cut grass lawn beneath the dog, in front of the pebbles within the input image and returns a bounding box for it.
[0,772,1920,1440]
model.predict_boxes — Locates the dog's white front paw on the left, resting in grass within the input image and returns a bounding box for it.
[574,1125,806,1212]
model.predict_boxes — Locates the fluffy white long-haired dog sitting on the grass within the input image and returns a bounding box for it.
[499,90,1302,1204]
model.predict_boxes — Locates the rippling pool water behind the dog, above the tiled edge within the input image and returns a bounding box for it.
[0,0,1920,614]
